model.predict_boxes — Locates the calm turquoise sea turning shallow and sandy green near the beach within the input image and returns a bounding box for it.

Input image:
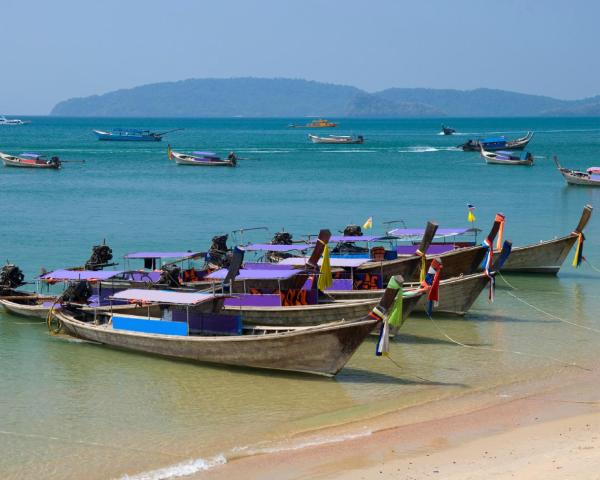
[0,118,600,479]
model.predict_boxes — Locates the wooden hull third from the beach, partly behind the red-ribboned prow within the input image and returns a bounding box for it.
[327,273,488,315]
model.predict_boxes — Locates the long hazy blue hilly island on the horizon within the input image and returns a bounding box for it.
[50,78,600,118]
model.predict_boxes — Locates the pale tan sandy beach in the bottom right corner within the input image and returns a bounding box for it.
[195,368,600,480]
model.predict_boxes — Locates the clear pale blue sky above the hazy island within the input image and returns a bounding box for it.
[0,0,600,115]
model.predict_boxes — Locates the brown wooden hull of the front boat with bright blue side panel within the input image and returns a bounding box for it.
[56,312,377,376]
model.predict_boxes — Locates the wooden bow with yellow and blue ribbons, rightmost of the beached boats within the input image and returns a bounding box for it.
[494,205,593,275]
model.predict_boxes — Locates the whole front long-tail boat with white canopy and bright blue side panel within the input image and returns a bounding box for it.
[49,279,402,376]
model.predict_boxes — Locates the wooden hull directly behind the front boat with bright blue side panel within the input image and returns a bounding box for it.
[223,290,420,327]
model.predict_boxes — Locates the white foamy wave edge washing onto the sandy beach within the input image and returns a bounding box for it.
[120,430,373,480]
